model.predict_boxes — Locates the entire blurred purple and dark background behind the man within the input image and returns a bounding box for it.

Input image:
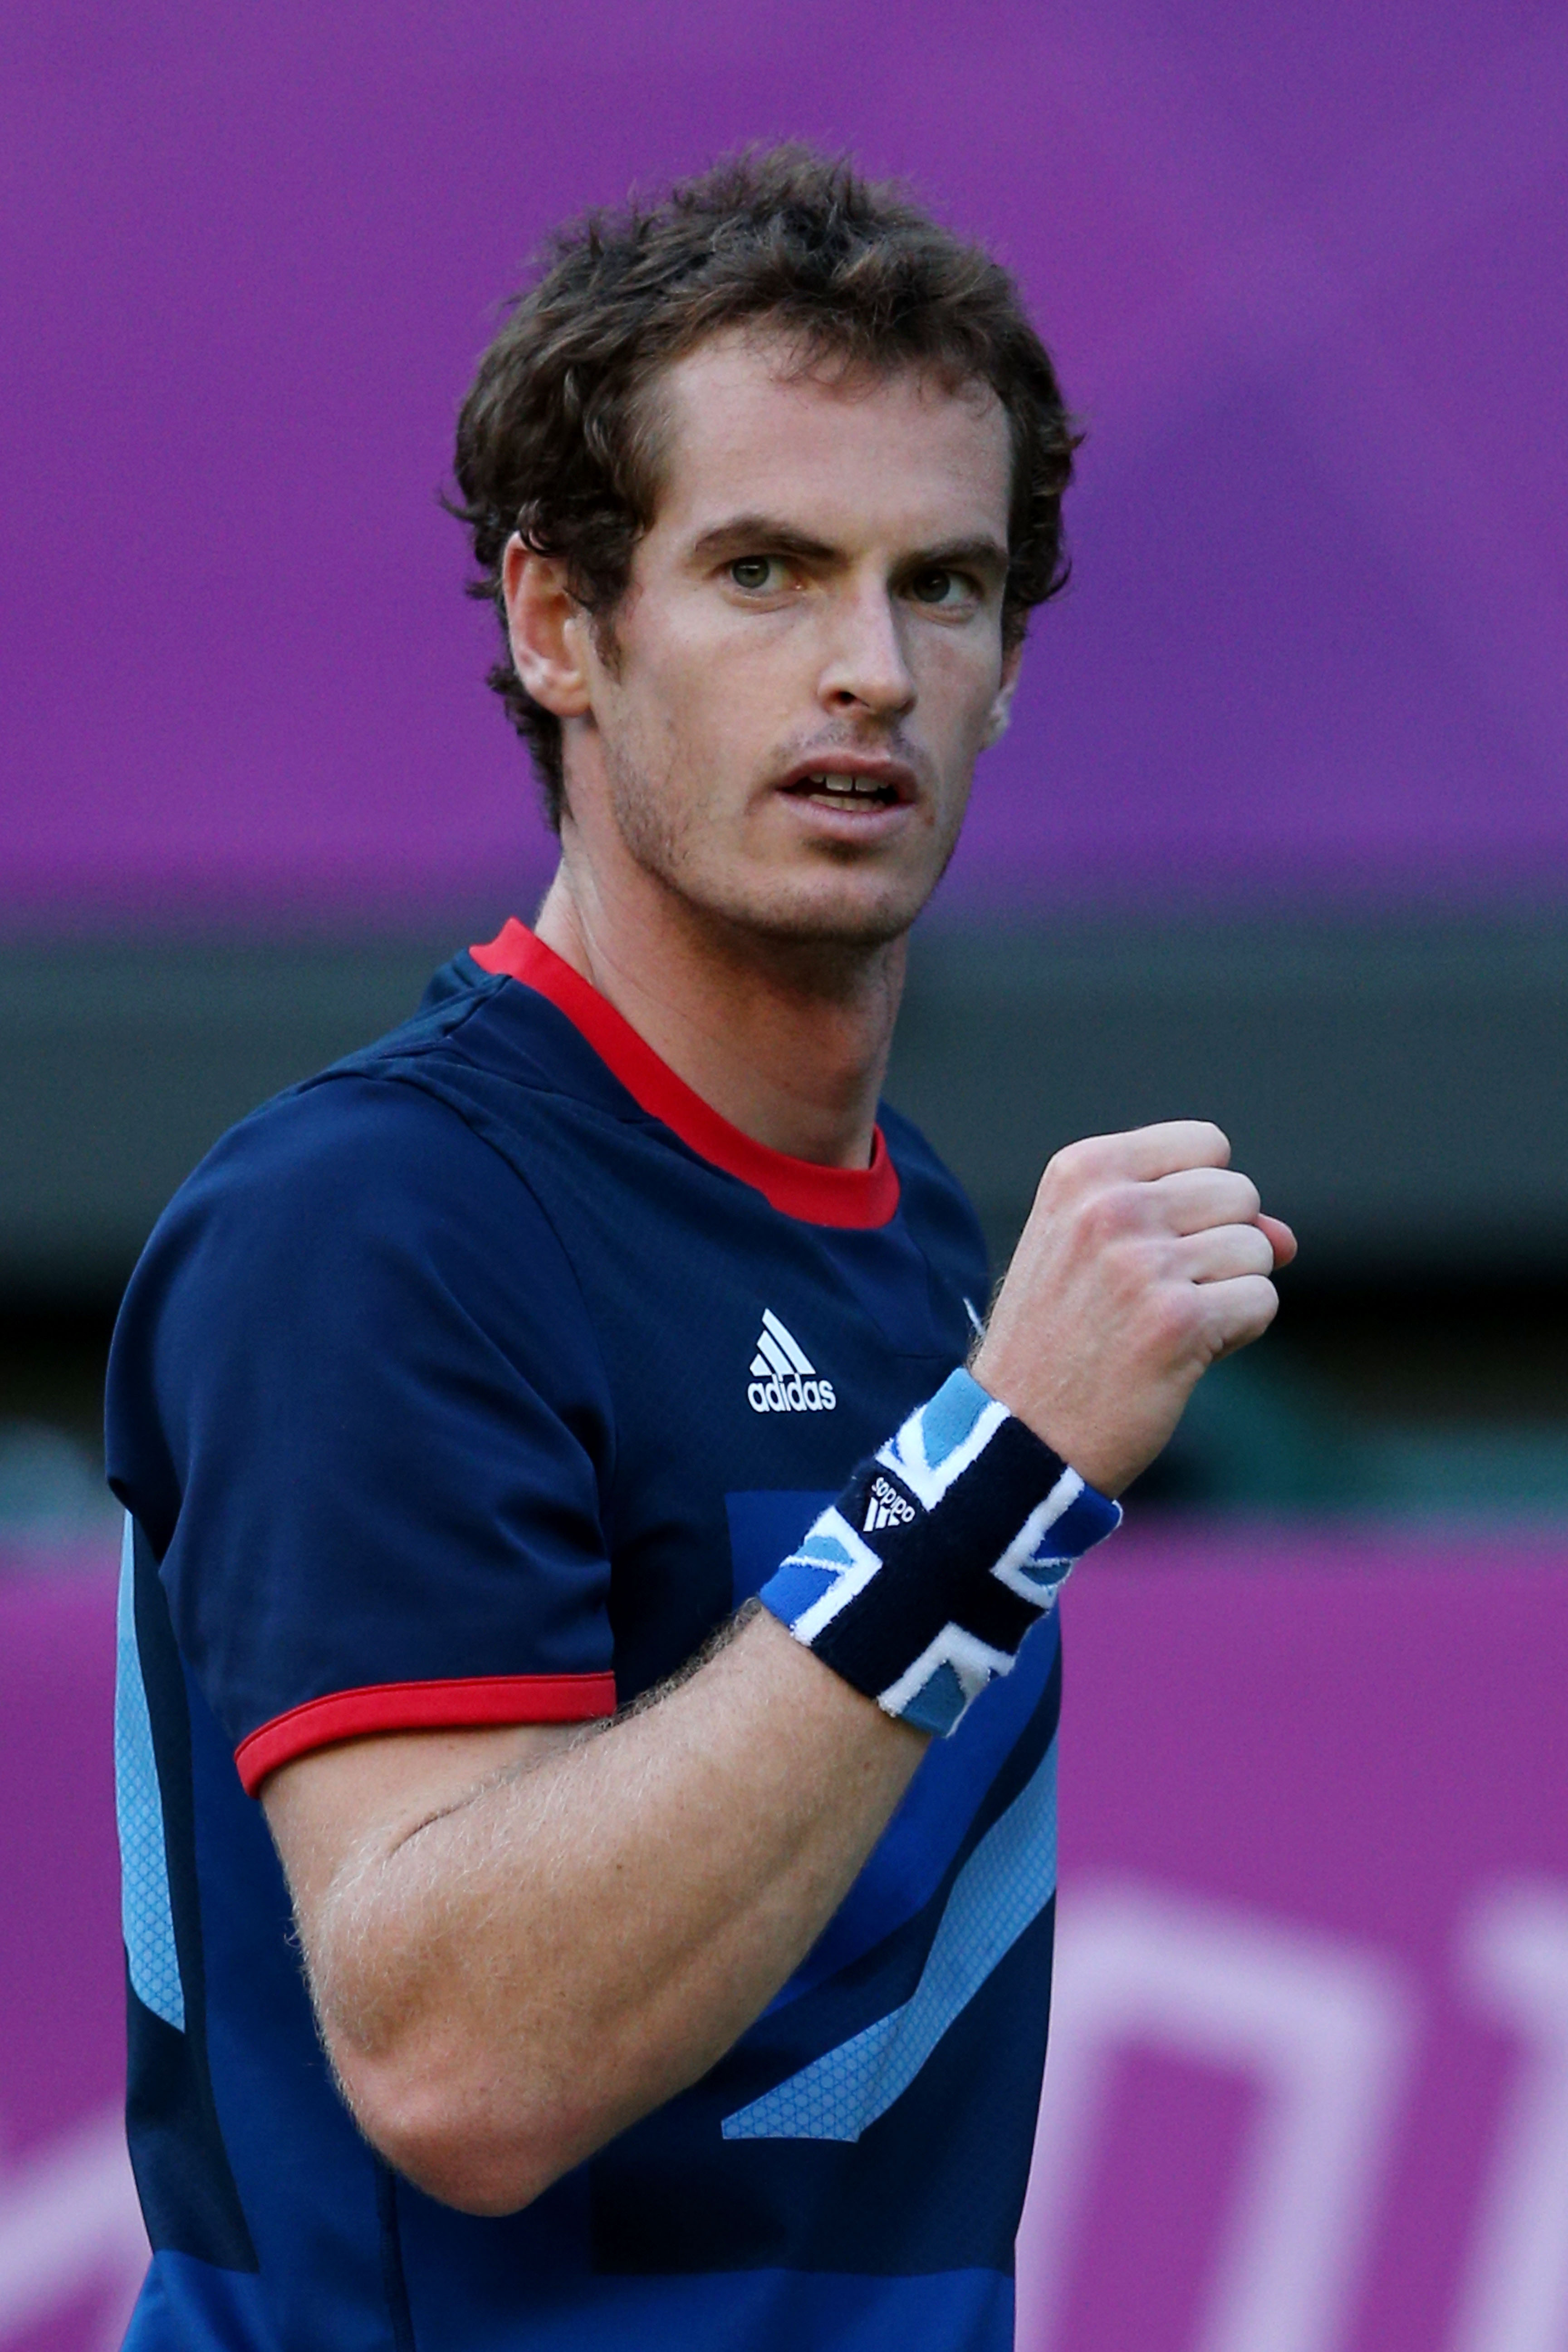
[0,0,1568,2352]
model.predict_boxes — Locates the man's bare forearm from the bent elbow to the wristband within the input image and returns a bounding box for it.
[285,1616,926,2211]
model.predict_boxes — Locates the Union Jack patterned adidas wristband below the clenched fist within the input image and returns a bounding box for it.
[762,1371,1122,1736]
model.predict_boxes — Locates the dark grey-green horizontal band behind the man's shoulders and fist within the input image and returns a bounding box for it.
[0,917,1568,1298]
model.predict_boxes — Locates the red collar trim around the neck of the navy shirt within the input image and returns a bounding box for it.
[468,915,898,1225]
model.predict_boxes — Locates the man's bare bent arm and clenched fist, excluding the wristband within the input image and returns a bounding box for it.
[263,1122,1293,2213]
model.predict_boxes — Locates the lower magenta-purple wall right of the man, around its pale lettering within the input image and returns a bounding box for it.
[1018,1529,1568,2352]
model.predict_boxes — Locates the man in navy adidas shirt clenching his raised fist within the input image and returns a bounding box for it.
[111,151,1293,2352]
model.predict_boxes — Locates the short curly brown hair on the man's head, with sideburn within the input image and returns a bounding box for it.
[451,143,1079,830]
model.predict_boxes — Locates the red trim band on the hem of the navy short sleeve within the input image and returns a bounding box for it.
[235,1675,616,1797]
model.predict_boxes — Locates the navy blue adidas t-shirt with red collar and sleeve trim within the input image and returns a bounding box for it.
[108,924,1058,2352]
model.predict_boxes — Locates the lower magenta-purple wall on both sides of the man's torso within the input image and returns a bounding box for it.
[0,1529,1568,2352]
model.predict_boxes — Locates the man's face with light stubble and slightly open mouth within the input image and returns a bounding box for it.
[569,334,1011,943]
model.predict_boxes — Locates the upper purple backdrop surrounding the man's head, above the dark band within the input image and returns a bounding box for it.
[0,0,1568,926]
